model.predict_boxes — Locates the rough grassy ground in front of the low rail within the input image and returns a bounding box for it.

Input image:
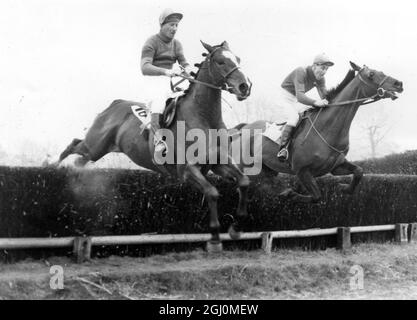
[0,243,417,299]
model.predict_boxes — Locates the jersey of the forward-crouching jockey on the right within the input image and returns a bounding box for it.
[281,66,327,106]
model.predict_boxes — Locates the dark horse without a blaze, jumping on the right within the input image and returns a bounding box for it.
[234,62,403,202]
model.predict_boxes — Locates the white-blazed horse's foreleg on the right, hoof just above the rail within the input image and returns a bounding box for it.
[212,164,250,239]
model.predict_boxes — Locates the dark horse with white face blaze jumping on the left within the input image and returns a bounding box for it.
[58,41,251,250]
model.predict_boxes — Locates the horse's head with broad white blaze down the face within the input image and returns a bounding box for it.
[201,41,252,101]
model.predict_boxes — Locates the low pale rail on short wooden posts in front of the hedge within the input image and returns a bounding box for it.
[0,223,417,263]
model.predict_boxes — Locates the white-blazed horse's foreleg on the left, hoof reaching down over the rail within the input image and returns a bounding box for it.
[183,165,220,244]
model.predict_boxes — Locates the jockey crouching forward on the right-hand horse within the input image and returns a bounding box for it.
[278,53,334,161]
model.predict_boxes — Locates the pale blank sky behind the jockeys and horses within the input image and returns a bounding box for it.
[0,0,417,164]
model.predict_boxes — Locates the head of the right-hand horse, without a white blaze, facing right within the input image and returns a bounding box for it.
[350,62,404,100]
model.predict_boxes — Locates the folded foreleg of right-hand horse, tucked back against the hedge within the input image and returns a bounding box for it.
[280,169,321,203]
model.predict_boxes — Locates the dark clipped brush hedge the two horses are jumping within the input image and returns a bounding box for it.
[0,167,417,237]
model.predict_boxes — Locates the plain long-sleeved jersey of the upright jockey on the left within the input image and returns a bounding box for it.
[141,33,188,69]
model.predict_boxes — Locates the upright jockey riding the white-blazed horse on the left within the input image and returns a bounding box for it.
[141,9,192,153]
